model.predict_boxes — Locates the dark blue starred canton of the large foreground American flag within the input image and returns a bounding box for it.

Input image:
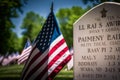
[35,12,61,53]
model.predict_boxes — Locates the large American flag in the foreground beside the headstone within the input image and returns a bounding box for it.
[21,11,71,80]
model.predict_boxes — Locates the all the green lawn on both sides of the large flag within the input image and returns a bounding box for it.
[0,65,73,80]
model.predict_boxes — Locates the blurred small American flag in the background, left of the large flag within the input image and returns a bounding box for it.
[18,40,32,64]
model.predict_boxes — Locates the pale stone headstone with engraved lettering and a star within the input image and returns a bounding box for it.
[73,2,120,80]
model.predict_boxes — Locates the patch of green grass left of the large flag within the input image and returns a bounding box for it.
[0,65,23,80]
